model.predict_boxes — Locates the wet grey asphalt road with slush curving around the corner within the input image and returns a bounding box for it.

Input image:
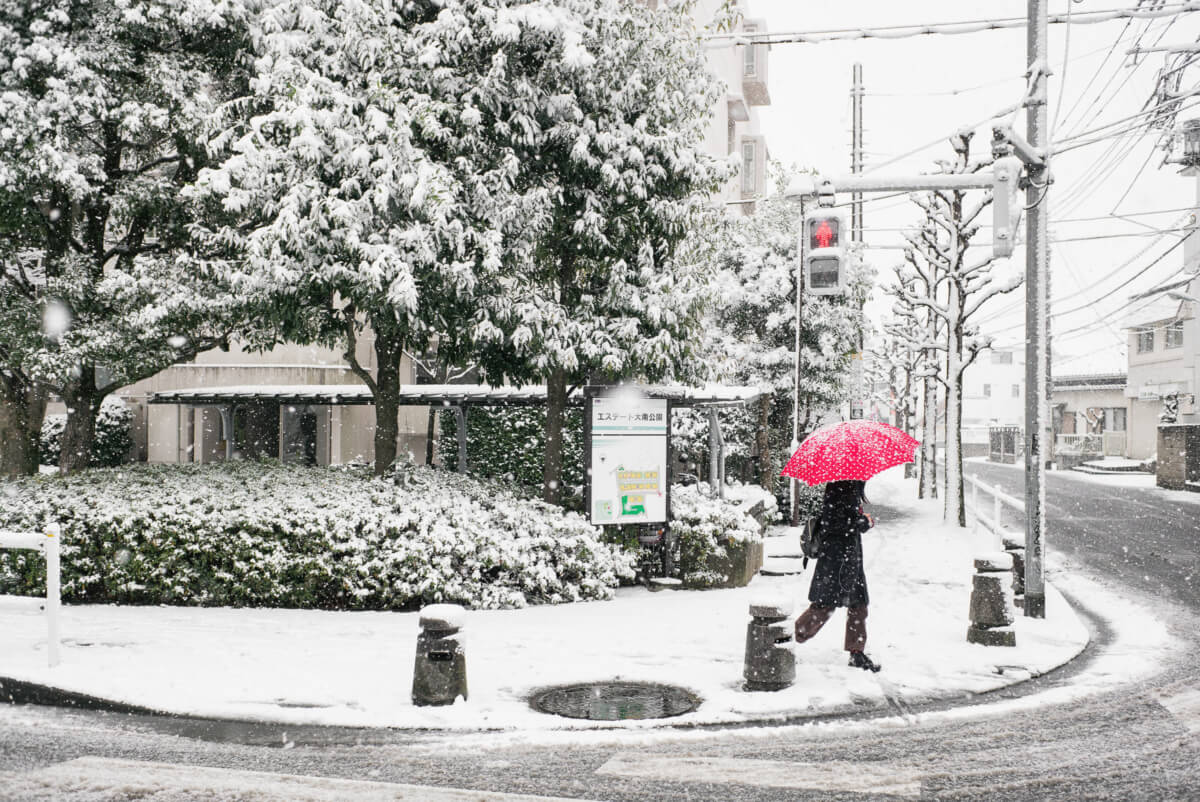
[0,466,1200,802]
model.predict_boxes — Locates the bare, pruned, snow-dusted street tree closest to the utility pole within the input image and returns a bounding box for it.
[896,132,1024,526]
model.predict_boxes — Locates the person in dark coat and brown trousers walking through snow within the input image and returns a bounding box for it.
[796,479,881,671]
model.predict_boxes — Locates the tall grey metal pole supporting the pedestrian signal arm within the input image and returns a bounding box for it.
[1025,0,1050,618]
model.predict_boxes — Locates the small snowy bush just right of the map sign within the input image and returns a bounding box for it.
[671,485,762,587]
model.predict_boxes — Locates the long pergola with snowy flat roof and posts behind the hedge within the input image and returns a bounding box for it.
[149,384,763,492]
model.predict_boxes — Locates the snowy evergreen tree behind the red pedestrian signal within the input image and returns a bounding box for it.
[704,164,871,495]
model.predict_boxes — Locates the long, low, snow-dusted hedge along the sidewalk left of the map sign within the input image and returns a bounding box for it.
[0,462,632,610]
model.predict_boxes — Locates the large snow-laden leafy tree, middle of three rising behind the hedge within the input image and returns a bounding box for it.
[189,0,583,472]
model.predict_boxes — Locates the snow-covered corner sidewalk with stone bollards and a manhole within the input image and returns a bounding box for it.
[0,469,1104,730]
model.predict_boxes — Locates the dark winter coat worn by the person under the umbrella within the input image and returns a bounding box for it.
[809,481,871,608]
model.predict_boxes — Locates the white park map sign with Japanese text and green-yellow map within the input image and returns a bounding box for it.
[587,391,671,525]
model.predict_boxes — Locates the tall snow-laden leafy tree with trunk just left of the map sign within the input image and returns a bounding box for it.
[465,0,728,501]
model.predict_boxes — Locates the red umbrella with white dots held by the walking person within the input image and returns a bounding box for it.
[780,420,920,485]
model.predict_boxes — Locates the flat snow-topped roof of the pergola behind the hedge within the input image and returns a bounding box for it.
[149,384,762,407]
